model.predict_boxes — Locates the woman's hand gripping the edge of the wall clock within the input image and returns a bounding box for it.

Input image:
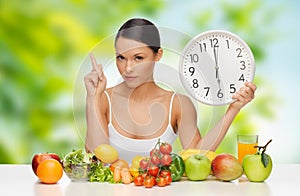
[230,82,256,109]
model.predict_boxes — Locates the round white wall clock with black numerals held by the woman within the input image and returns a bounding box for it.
[179,31,255,105]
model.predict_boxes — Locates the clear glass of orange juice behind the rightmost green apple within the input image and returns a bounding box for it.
[237,135,258,164]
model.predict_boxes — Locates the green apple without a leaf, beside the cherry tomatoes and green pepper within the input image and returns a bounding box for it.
[184,154,211,180]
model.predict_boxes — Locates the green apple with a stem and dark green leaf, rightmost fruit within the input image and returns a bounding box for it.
[242,153,273,182]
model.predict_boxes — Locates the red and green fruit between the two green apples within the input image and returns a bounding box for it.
[211,153,243,181]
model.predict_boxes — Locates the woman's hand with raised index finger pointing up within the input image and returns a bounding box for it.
[84,53,106,96]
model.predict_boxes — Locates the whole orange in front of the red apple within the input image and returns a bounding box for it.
[36,159,63,184]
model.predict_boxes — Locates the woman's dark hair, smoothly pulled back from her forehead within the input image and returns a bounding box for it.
[115,18,160,53]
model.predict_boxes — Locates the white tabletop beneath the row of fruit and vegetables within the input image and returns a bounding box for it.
[0,164,300,196]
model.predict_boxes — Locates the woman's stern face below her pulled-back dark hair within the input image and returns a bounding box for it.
[116,37,162,88]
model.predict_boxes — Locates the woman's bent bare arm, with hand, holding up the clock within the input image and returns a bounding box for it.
[178,83,256,151]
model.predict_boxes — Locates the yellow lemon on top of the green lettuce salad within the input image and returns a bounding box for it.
[94,144,119,163]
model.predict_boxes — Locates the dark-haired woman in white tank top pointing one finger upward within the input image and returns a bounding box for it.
[85,18,256,161]
